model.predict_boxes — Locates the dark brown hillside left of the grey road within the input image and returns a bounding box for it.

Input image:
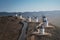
[0,16,22,40]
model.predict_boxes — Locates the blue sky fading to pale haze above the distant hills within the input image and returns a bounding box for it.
[0,0,60,12]
